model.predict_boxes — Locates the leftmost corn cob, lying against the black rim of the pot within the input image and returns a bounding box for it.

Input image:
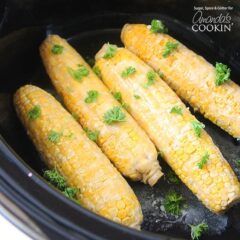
[14,85,142,228]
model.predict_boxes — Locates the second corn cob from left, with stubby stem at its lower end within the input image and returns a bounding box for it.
[40,35,162,186]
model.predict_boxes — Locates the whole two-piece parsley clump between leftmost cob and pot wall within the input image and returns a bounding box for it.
[43,169,79,200]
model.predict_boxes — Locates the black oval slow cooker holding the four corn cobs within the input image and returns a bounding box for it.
[0,0,240,240]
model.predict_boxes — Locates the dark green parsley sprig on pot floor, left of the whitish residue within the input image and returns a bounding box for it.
[163,191,185,216]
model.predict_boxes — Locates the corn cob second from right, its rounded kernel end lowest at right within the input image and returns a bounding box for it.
[96,45,240,213]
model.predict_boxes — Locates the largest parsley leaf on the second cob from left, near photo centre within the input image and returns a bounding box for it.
[103,106,126,125]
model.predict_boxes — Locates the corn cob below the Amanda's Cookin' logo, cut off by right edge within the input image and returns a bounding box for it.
[121,24,240,138]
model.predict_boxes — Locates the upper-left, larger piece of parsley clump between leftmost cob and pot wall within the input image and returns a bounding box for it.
[43,169,67,191]
